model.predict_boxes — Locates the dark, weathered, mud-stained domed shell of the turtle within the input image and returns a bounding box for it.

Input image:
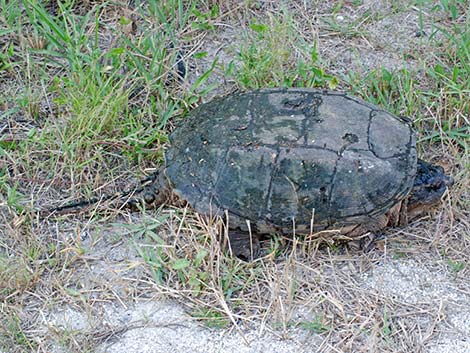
[165,89,417,232]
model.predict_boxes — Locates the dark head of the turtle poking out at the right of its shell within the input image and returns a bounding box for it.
[407,159,454,218]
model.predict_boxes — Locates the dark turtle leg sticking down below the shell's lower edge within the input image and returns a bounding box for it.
[226,230,261,262]
